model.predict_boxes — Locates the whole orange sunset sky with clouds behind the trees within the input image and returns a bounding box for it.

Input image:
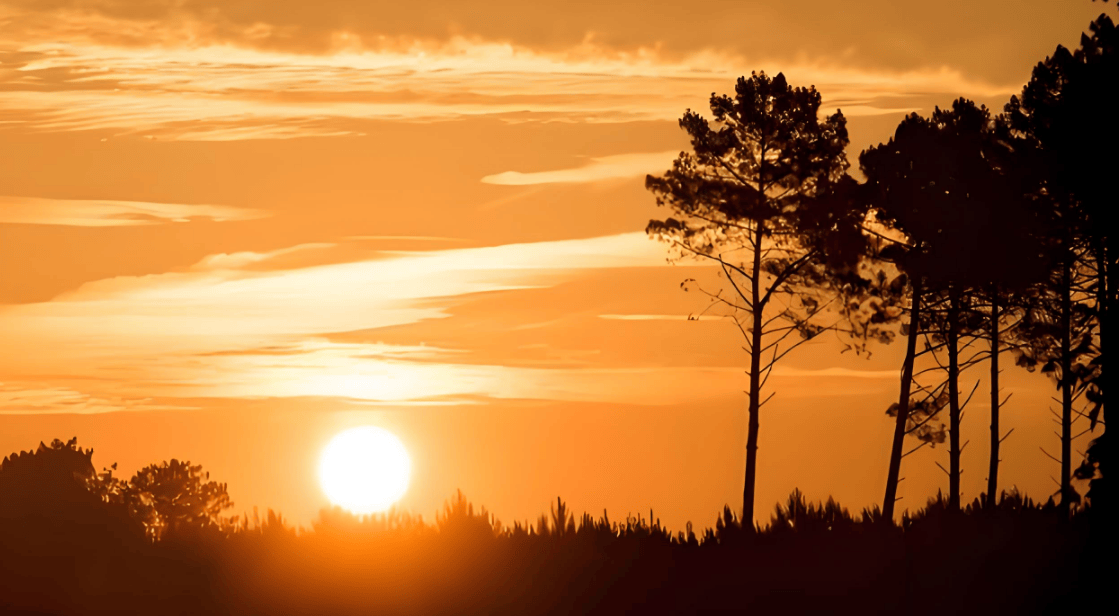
[0,0,1108,529]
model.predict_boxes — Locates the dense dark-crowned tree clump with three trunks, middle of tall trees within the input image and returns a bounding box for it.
[859,99,1029,519]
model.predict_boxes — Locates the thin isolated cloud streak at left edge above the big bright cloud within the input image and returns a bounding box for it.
[0,196,270,226]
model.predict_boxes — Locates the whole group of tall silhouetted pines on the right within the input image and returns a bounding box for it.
[646,4,1119,528]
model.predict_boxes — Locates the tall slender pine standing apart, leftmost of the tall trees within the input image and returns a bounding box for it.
[646,73,884,528]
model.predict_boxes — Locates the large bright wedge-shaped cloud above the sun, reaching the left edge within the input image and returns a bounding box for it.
[0,233,664,412]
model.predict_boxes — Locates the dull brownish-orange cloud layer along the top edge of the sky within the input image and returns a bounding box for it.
[0,0,1099,81]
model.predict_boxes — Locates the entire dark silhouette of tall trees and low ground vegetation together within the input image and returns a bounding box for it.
[0,1,1119,614]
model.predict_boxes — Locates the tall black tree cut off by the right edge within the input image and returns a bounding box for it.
[1006,15,1119,516]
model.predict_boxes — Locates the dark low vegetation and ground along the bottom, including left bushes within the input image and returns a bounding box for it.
[0,440,1111,615]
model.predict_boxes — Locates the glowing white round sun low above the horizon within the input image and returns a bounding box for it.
[319,426,412,514]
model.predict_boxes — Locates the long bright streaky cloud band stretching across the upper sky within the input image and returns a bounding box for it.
[0,36,1021,141]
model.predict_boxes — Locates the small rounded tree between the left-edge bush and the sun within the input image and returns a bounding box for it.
[123,459,233,540]
